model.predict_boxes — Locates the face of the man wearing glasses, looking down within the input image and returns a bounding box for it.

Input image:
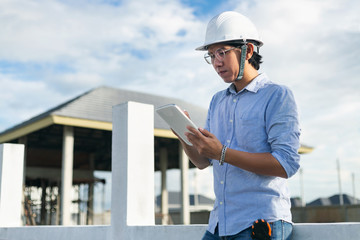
[208,44,241,83]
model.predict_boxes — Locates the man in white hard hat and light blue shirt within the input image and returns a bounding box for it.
[180,12,300,239]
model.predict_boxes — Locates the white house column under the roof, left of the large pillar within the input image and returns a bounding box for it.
[61,126,74,225]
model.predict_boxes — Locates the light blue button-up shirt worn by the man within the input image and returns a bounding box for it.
[205,74,300,236]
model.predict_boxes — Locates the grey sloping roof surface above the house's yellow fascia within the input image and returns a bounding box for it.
[0,86,207,142]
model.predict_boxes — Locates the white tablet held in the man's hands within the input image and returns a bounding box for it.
[156,104,198,146]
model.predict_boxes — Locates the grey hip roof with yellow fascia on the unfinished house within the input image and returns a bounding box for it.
[0,86,313,154]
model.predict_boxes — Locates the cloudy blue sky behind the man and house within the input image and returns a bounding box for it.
[0,0,360,208]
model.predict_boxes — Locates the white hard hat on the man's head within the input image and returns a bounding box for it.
[196,11,263,51]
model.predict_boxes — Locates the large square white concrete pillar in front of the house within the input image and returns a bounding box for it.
[111,102,155,239]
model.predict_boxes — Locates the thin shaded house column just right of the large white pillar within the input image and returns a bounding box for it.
[160,148,169,225]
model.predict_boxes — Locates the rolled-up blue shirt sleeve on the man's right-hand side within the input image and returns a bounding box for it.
[266,86,301,178]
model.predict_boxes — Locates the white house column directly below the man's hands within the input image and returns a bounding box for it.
[179,144,190,225]
